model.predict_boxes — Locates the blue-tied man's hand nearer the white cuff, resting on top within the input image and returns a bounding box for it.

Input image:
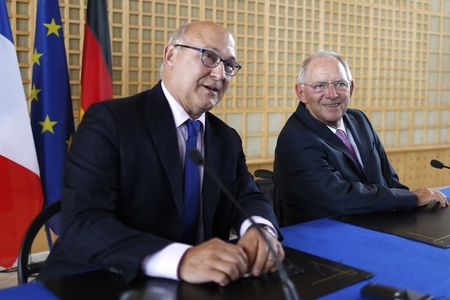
[178,238,248,286]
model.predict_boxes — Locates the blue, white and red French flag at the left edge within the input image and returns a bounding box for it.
[0,0,42,268]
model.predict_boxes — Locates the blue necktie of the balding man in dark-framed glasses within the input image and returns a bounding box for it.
[183,119,202,243]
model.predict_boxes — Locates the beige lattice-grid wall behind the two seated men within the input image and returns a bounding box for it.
[7,0,450,252]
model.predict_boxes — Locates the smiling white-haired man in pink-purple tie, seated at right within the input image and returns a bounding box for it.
[274,51,448,224]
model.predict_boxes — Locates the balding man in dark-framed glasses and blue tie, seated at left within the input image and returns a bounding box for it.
[39,22,284,285]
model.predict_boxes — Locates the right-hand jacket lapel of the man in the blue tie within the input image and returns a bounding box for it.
[203,113,225,238]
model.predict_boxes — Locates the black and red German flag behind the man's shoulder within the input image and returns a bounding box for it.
[80,0,112,120]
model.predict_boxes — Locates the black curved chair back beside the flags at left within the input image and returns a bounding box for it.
[17,201,61,284]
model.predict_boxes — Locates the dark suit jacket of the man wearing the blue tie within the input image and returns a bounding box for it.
[39,83,278,280]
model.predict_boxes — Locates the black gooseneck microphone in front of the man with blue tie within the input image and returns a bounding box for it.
[188,149,300,300]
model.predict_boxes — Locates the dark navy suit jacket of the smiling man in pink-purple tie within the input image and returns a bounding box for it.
[274,103,417,224]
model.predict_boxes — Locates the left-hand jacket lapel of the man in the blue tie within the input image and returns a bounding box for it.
[144,82,183,213]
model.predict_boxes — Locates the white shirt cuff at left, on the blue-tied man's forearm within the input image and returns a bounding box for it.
[142,243,192,280]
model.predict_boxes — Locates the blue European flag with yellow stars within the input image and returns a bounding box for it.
[30,0,74,234]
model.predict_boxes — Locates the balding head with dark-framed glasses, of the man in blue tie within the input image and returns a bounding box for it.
[161,21,240,119]
